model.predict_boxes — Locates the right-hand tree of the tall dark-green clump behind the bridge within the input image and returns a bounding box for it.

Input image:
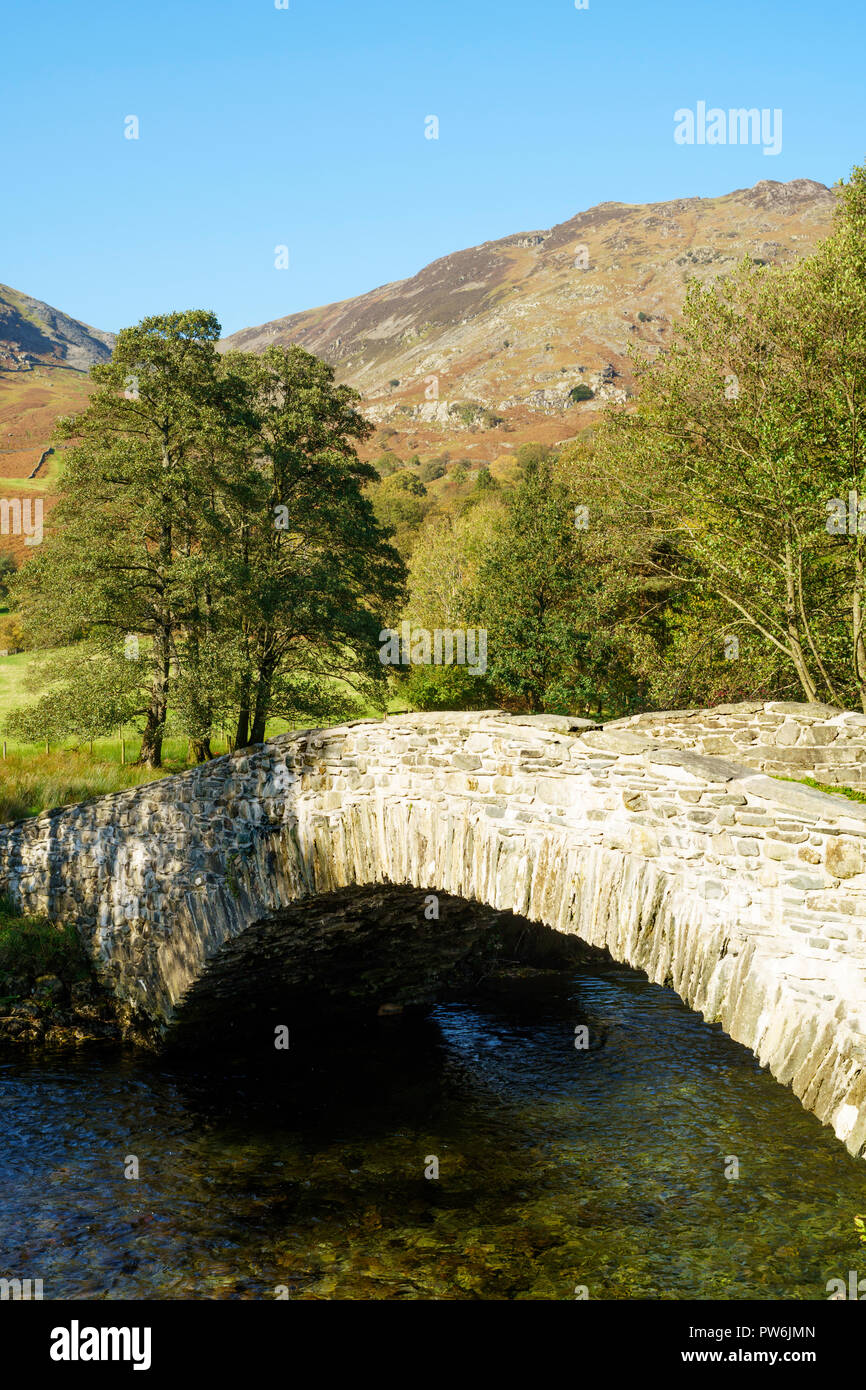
[208,346,405,746]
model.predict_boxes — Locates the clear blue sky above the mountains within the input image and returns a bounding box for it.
[0,0,866,332]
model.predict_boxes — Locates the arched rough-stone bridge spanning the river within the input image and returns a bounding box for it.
[0,703,866,1155]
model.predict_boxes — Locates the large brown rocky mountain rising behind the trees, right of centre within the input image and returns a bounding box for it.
[222,179,835,455]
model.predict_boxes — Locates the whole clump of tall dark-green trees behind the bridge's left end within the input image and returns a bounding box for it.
[7,313,405,766]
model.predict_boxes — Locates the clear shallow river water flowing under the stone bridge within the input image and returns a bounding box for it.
[0,966,866,1300]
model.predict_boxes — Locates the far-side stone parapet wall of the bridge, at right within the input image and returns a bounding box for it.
[605,701,866,790]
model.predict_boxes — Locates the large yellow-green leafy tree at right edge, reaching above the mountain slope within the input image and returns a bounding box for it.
[596,159,866,709]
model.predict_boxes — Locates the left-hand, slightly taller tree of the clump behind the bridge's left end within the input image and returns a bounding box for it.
[14,311,225,767]
